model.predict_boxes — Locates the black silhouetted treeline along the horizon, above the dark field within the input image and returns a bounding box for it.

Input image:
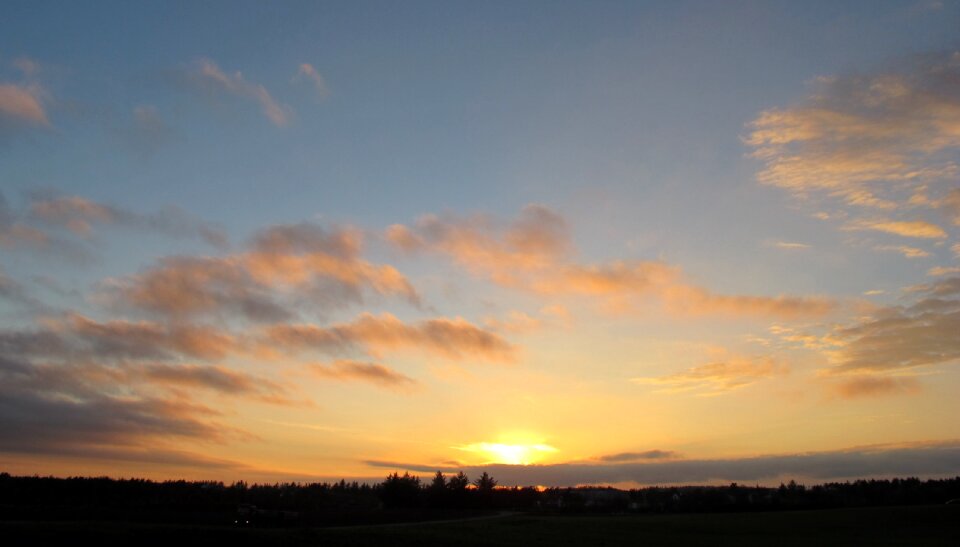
[0,472,960,525]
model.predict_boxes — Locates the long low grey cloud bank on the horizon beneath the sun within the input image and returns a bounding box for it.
[364,441,960,486]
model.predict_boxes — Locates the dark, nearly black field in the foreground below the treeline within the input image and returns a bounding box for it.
[0,505,960,547]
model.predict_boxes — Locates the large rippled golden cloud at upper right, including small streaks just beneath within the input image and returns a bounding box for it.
[744,52,960,258]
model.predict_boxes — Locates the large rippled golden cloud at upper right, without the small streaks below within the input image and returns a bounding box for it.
[745,53,960,209]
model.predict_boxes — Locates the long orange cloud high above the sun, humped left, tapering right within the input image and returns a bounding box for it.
[385,204,836,318]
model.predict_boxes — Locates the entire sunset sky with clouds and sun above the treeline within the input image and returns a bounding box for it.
[0,0,960,486]
